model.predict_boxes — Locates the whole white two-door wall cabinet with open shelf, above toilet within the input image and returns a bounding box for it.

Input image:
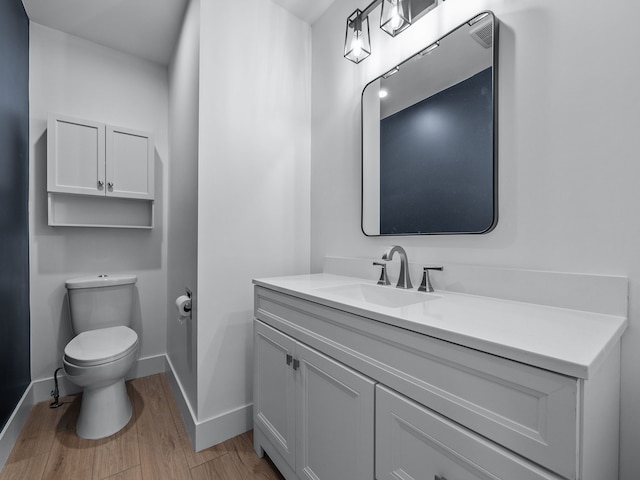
[47,114,155,228]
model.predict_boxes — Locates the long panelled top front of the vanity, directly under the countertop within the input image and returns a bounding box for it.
[255,287,579,480]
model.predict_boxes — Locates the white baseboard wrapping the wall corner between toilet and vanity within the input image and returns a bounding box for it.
[166,357,253,452]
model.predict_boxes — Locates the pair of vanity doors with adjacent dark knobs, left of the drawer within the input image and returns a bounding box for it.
[254,322,374,480]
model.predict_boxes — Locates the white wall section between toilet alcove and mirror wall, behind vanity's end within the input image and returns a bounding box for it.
[198,0,311,428]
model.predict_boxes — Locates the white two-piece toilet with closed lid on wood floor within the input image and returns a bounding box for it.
[63,275,138,439]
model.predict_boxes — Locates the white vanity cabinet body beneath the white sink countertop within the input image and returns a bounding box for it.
[254,281,620,480]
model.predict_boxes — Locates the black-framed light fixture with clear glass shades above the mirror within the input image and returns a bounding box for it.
[344,0,444,63]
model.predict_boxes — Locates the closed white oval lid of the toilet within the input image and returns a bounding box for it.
[64,327,138,367]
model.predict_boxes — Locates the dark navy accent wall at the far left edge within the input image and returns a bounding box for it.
[0,0,31,429]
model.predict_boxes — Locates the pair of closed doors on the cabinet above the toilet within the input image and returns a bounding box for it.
[47,114,154,200]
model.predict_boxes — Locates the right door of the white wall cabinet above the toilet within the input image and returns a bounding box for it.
[106,125,154,200]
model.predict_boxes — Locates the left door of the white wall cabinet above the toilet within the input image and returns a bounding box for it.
[47,115,106,196]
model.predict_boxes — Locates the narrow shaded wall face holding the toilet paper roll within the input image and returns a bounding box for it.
[167,0,200,412]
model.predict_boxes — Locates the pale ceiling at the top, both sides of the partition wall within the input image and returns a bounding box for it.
[22,0,335,65]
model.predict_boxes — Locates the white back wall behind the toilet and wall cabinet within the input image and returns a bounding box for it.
[29,23,168,380]
